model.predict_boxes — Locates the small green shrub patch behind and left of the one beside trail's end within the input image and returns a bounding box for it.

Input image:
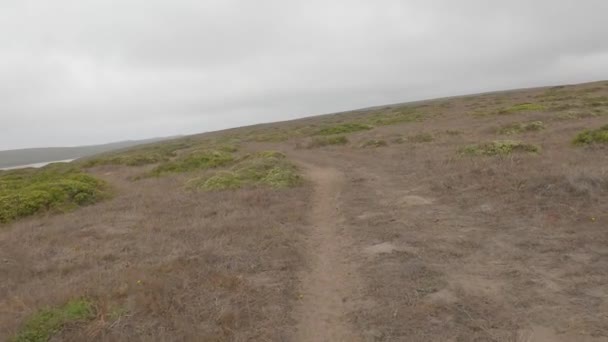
[150,150,234,176]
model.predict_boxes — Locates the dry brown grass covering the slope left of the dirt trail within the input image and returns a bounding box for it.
[0,168,309,341]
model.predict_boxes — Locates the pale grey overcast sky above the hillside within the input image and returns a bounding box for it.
[0,0,608,150]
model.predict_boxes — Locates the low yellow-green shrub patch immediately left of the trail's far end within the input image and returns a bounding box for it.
[188,151,302,191]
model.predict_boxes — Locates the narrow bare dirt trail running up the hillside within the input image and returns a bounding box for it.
[296,164,360,342]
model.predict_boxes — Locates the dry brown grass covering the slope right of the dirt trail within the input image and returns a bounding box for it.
[333,130,608,341]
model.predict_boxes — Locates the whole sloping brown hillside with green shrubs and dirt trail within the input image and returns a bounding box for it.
[0,81,608,342]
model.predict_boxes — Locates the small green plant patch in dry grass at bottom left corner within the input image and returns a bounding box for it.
[10,299,95,342]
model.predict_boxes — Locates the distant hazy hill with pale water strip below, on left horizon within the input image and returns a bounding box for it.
[0,137,174,168]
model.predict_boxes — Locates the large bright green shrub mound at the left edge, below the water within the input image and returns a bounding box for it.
[0,165,108,223]
